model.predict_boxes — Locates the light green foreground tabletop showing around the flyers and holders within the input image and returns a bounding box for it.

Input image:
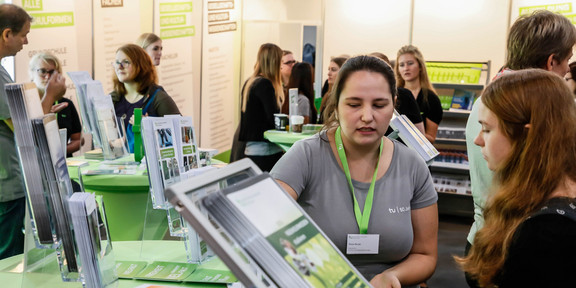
[0,241,226,288]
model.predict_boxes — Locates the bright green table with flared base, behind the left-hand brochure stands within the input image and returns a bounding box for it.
[68,154,168,241]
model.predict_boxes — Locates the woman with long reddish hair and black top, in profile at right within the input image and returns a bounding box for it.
[457,69,576,288]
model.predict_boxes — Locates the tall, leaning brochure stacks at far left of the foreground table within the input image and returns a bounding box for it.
[0,83,79,280]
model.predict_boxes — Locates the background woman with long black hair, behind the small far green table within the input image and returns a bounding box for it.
[282,62,318,124]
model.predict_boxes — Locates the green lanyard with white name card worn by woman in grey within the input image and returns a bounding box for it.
[334,127,384,254]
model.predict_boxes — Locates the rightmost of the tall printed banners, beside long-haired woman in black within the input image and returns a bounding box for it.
[200,0,241,152]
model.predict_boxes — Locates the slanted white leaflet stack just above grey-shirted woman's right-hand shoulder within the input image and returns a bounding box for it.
[389,110,440,165]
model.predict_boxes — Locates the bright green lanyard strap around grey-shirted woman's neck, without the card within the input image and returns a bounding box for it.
[335,127,384,234]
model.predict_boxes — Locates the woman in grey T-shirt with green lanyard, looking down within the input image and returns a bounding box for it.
[270,56,438,288]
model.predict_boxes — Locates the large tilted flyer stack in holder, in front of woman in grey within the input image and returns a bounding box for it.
[166,159,370,287]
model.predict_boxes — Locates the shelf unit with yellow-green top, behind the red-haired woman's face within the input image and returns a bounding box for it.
[426,61,490,217]
